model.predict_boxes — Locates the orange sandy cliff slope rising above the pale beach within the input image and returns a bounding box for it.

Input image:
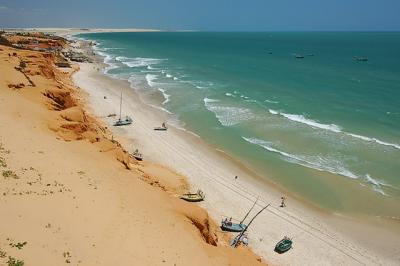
[0,34,263,265]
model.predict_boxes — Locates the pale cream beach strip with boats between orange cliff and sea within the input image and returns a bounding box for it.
[73,36,399,265]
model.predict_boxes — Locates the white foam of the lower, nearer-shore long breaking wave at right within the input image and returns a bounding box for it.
[242,137,359,179]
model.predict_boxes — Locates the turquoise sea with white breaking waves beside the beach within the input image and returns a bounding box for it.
[79,32,400,217]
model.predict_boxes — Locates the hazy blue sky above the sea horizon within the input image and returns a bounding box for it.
[0,0,400,31]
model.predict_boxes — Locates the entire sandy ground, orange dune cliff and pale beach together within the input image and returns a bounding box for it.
[0,30,400,265]
